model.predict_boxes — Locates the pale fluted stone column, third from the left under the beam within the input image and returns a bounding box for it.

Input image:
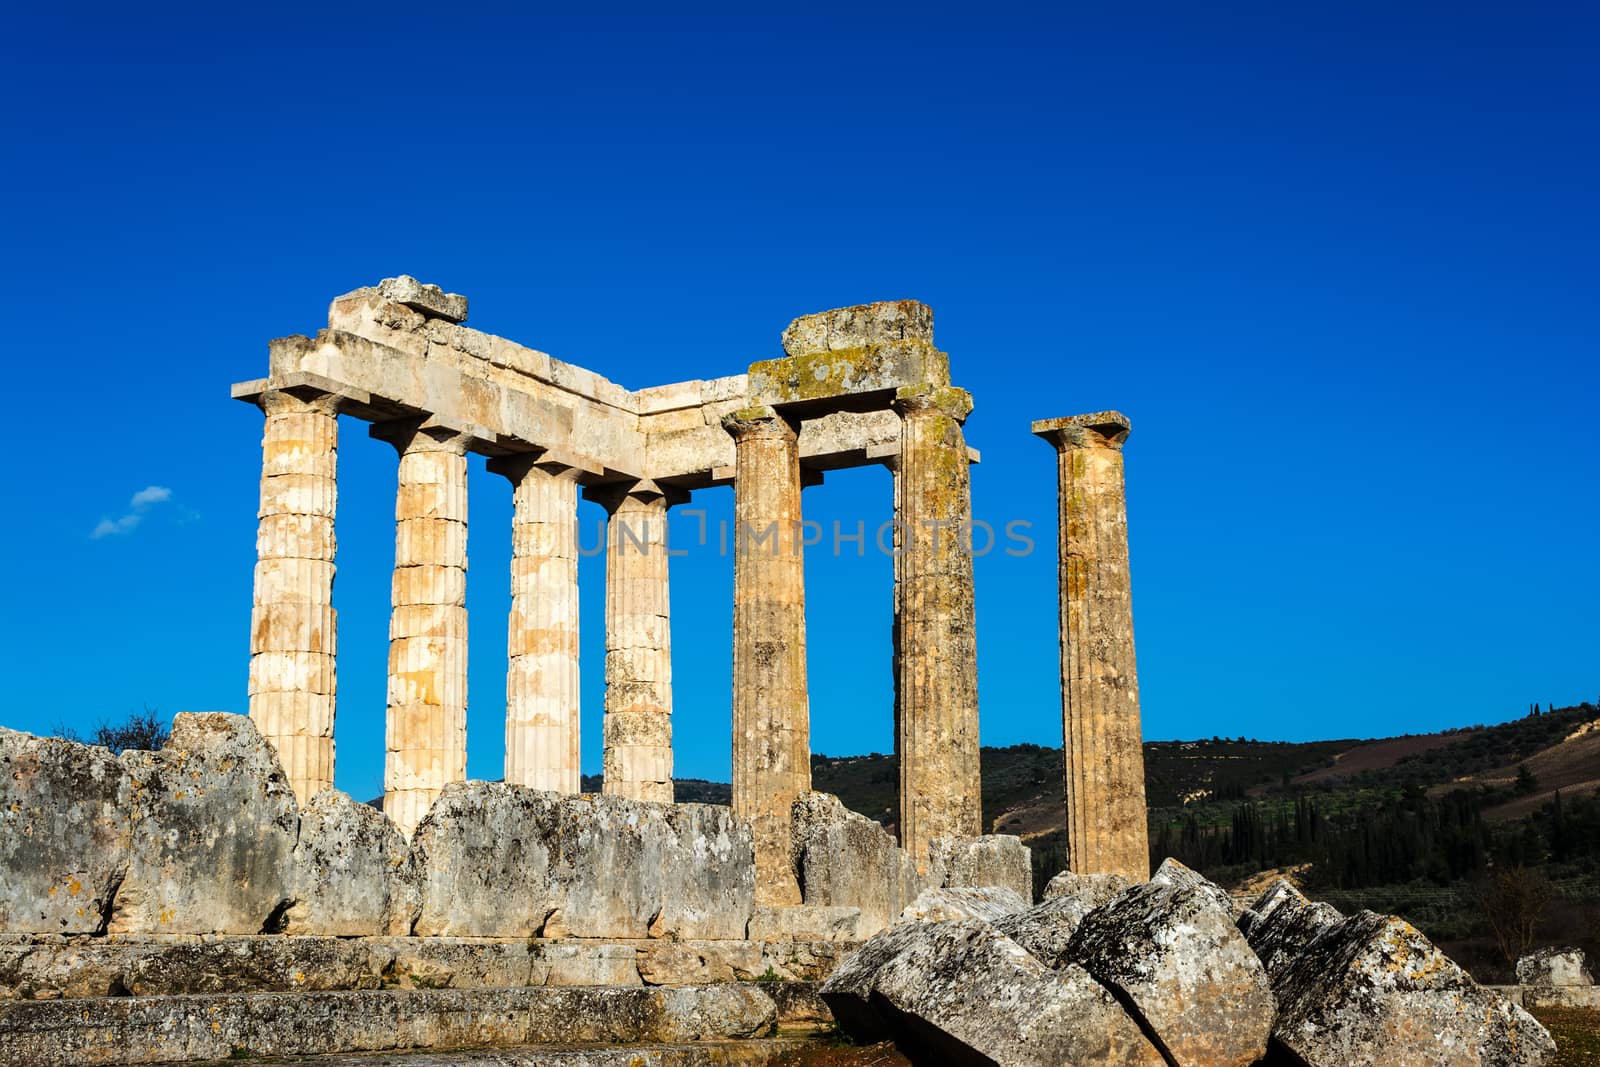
[490,456,581,793]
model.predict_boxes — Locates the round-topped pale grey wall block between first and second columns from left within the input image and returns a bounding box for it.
[285,789,419,937]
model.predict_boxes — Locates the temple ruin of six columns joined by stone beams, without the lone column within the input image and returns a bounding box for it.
[234,277,981,902]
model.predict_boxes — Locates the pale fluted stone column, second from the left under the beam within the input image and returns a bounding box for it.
[373,422,467,837]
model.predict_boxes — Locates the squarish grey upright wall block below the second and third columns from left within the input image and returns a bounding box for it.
[411,782,562,937]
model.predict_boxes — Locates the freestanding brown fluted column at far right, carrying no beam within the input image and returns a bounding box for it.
[1034,411,1150,881]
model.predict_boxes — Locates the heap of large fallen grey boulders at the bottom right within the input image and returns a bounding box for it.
[821,861,1554,1067]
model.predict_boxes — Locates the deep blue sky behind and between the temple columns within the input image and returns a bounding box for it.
[0,3,1600,797]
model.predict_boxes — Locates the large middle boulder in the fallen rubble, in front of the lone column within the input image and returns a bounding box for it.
[1067,880,1274,1067]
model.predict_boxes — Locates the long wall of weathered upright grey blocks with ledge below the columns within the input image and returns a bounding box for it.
[0,713,1027,997]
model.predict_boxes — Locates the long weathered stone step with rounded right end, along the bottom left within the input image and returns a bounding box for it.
[0,982,779,1067]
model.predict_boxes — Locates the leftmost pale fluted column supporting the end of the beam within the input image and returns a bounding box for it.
[250,392,339,805]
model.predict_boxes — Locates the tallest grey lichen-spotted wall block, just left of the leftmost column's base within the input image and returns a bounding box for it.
[109,712,299,934]
